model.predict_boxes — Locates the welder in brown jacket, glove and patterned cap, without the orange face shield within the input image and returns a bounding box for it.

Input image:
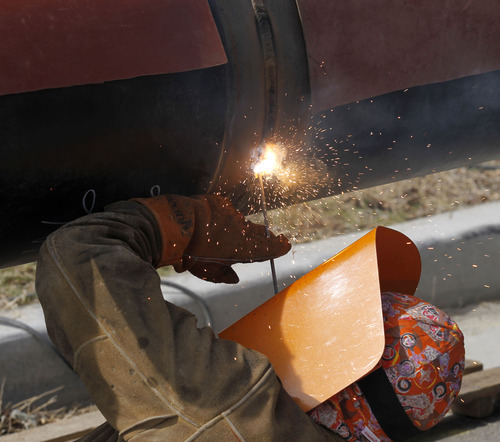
[37,195,463,441]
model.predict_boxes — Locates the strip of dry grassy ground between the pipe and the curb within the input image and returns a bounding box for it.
[0,161,500,310]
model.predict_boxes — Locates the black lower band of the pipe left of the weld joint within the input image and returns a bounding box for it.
[0,66,226,265]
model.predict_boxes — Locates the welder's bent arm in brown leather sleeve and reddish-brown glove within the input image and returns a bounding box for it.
[37,198,335,441]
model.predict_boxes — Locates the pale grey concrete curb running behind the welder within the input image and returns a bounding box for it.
[0,203,500,407]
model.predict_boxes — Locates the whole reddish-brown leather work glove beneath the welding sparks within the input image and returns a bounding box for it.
[134,195,291,284]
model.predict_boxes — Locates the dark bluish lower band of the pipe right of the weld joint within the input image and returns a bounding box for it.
[313,71,500,195]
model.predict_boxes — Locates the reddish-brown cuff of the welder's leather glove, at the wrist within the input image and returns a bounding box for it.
[132,195,194,267]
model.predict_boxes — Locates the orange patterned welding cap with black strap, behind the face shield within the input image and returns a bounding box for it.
[309,292,465,441]
